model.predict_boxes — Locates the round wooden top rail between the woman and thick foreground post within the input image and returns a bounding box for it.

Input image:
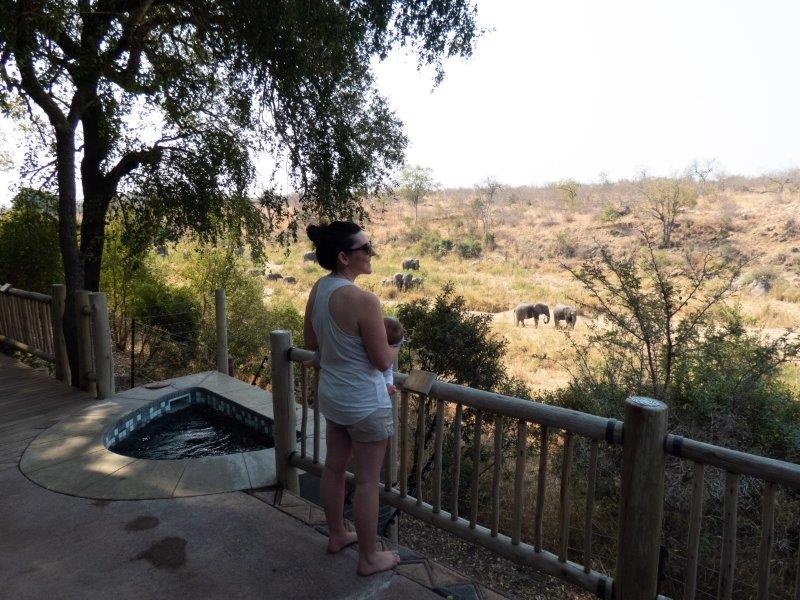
[289,348,622,444]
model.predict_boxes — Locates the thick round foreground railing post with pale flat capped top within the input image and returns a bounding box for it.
[614,396,667,600]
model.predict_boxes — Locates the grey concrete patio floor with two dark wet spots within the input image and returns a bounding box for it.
[0,469,441,600]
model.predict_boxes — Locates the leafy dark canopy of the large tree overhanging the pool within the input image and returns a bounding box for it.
[0,0,479,382]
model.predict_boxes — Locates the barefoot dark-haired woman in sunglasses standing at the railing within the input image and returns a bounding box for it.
[303,221,400,575]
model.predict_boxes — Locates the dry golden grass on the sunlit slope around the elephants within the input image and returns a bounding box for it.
[245,186,800,390]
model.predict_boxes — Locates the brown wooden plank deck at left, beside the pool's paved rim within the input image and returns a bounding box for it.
[0,354,94,471]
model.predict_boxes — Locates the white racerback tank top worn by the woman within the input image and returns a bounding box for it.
[311,275,392,425]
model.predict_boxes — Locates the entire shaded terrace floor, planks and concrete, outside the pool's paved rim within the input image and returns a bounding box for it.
[0,355,500,600]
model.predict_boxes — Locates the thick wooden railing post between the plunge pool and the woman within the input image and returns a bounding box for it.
[269,330,302,494]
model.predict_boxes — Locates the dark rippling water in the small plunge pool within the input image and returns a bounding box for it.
[109,404,275,460]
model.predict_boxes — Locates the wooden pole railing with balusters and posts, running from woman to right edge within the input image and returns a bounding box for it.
[271,331,800,600]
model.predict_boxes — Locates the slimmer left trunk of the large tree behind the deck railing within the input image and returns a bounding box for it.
[56,126,83,387]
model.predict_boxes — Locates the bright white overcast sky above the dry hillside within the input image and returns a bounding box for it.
[0,0,800,205]
